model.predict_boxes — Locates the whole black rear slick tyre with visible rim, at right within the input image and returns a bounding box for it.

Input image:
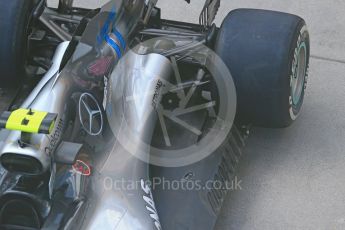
[215,9,310,128]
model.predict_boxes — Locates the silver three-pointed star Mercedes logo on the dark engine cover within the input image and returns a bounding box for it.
[79,93,104,136]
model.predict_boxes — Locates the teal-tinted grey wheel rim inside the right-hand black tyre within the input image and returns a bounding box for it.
[291,42,307,106]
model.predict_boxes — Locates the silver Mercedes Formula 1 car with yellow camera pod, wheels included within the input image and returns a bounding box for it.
[0,0,310,230]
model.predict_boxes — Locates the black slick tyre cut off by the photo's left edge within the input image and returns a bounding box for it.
[0,0,34,87]
